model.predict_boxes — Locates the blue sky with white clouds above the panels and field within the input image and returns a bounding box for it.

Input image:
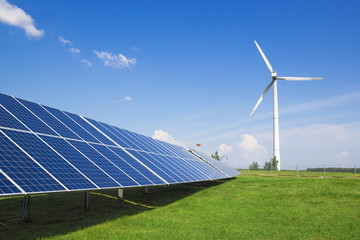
[0,0,360,169]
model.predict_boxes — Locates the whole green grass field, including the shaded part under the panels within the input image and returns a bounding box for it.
[0,172,360,240]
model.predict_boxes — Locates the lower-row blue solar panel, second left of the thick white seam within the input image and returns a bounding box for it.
[69,140,138,187]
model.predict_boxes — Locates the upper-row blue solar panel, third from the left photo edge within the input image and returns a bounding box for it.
[18,99,80,139]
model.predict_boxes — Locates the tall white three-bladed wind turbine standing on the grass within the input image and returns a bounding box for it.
[250,41,322,171]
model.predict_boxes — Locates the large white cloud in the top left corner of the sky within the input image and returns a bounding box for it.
[0,0,44,38]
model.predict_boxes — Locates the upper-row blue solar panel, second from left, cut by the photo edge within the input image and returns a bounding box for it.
[0,93,57,135]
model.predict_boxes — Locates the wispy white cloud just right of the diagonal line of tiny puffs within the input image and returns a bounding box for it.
[93,50,136,69]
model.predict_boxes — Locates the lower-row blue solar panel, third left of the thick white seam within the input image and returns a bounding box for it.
[41,136,120,188]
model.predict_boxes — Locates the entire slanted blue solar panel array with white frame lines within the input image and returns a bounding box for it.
[0,94,240,196]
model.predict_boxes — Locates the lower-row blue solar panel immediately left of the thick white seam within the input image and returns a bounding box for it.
[91,144,153,186]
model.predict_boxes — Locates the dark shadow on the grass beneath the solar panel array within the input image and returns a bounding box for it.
[0,181,228,239]
